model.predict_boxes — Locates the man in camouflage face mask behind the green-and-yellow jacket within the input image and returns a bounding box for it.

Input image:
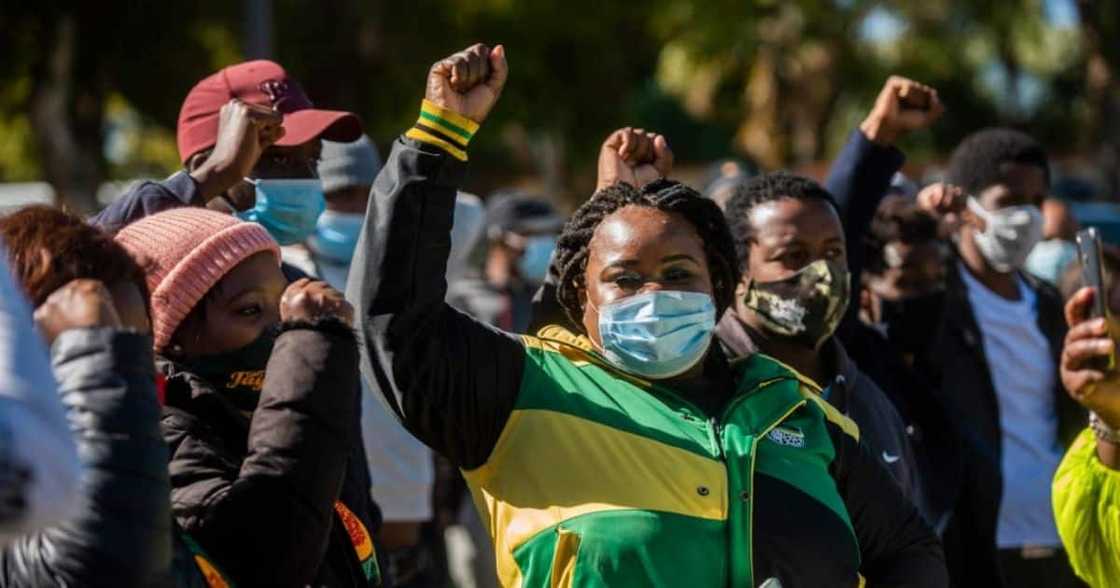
[716,172,923,521]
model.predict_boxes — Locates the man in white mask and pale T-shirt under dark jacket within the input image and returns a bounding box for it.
[915,129,1085,587]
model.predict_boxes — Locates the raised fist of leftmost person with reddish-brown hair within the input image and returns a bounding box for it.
[35,280,121,345]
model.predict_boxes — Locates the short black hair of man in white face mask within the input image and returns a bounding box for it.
[949,128,1051,195]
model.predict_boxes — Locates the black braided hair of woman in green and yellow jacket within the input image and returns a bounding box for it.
[552,179,739,326]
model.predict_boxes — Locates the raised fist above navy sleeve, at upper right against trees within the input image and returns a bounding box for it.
[859,75,945,144]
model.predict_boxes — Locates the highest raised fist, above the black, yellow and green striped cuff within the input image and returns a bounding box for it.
[424,43,510,123]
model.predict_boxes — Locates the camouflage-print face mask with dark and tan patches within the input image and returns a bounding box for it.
[746,260,851,349]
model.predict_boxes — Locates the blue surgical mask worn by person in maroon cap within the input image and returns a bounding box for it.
[237,178,327,245]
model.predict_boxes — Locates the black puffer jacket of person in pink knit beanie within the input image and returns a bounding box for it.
[160,320,376,587]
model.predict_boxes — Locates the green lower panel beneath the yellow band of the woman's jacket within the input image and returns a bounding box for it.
[514,511,728,588]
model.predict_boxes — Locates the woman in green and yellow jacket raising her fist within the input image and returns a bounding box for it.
[347,45,948,588]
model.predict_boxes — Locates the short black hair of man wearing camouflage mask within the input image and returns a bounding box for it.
[726,171,840,271]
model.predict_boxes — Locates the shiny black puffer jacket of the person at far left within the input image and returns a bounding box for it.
[0,328,173,587]
